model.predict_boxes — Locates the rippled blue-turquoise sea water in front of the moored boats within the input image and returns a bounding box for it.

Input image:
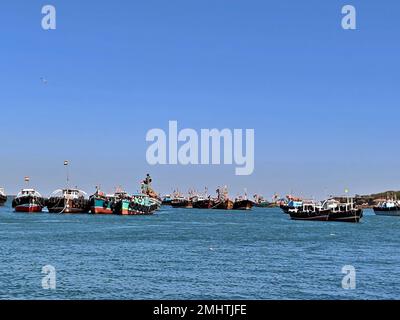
[0,203,400,299]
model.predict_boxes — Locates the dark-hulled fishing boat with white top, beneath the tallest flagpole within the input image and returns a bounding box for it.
[47,188,90,213]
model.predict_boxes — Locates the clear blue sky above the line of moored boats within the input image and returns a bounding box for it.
[0,0,400,197]
